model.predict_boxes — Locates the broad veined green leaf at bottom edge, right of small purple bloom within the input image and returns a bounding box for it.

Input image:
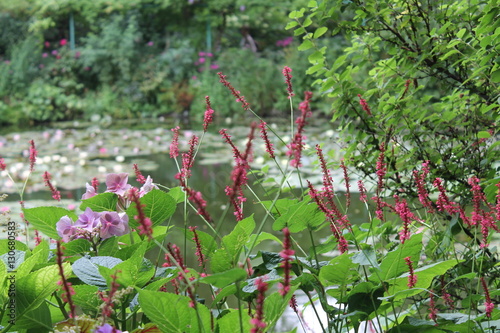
[139,290,211,333]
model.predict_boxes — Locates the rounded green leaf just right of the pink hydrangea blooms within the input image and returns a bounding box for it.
[127,189,177,228]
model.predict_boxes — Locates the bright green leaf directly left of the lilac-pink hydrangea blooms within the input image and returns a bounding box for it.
[23,207,76,239]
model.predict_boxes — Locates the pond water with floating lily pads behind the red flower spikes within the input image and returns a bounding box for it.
[0,118,368,332]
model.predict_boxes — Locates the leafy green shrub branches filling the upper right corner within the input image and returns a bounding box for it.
[287,0,500,198]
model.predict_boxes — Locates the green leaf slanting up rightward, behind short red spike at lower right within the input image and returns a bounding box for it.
[370,233,423,281]
